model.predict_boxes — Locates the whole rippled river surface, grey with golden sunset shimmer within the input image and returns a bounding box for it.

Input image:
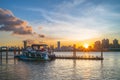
[0,52,120,80]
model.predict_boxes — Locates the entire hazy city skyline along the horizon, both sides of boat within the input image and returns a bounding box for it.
[0,38,120,50]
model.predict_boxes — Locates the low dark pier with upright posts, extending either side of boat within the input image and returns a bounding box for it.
[0,44,104,60]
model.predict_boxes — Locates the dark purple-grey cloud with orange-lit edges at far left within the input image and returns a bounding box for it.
[0,8,33,35]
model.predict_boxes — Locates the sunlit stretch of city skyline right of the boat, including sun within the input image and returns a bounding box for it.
[54,38,120,51]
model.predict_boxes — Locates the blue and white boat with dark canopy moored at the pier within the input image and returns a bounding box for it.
[15,44,55,60]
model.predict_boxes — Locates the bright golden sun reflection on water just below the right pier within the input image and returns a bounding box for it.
[73,58,103,80]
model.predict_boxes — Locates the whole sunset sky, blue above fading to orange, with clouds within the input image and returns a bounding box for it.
[0,0,120,46]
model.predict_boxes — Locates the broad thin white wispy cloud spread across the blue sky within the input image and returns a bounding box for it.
[27,0,120,40]
